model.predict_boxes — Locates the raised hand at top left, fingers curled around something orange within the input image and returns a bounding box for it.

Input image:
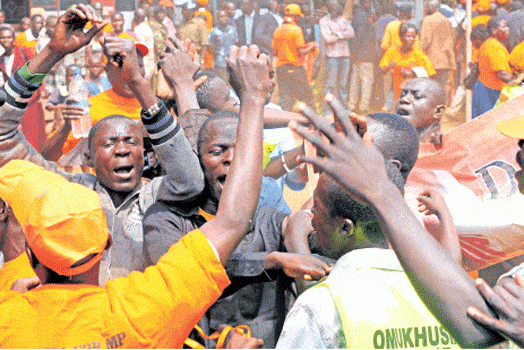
[48,4,109,55]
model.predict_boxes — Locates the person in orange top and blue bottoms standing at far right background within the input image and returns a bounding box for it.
[471,17,511,119]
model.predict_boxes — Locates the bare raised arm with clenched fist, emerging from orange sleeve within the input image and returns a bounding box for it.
[200,45,271,265]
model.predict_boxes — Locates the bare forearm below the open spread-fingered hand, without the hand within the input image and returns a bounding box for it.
[370,185,503,348]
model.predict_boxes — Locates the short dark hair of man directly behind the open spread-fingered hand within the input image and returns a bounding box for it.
[366,113,419,179]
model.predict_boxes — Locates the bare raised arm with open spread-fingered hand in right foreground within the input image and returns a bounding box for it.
[291,96,504,348]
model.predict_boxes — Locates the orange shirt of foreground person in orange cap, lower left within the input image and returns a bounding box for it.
[0,230,229,348]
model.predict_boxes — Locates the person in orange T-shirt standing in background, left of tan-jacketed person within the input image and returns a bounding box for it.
[379,22,436,101]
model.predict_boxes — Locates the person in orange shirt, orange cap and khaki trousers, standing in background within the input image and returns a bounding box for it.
[271,4,317,111]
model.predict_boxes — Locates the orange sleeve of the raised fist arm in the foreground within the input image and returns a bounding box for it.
[105,230,229,348]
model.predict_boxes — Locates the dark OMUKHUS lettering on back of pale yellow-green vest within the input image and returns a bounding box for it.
[373,326,457,349]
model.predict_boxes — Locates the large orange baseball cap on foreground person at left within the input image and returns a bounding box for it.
[0,160,111,276]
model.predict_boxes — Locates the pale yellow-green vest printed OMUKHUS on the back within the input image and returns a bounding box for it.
[317,249,459,349]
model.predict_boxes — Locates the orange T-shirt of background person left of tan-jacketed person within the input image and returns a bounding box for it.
[379,46,436,101]
